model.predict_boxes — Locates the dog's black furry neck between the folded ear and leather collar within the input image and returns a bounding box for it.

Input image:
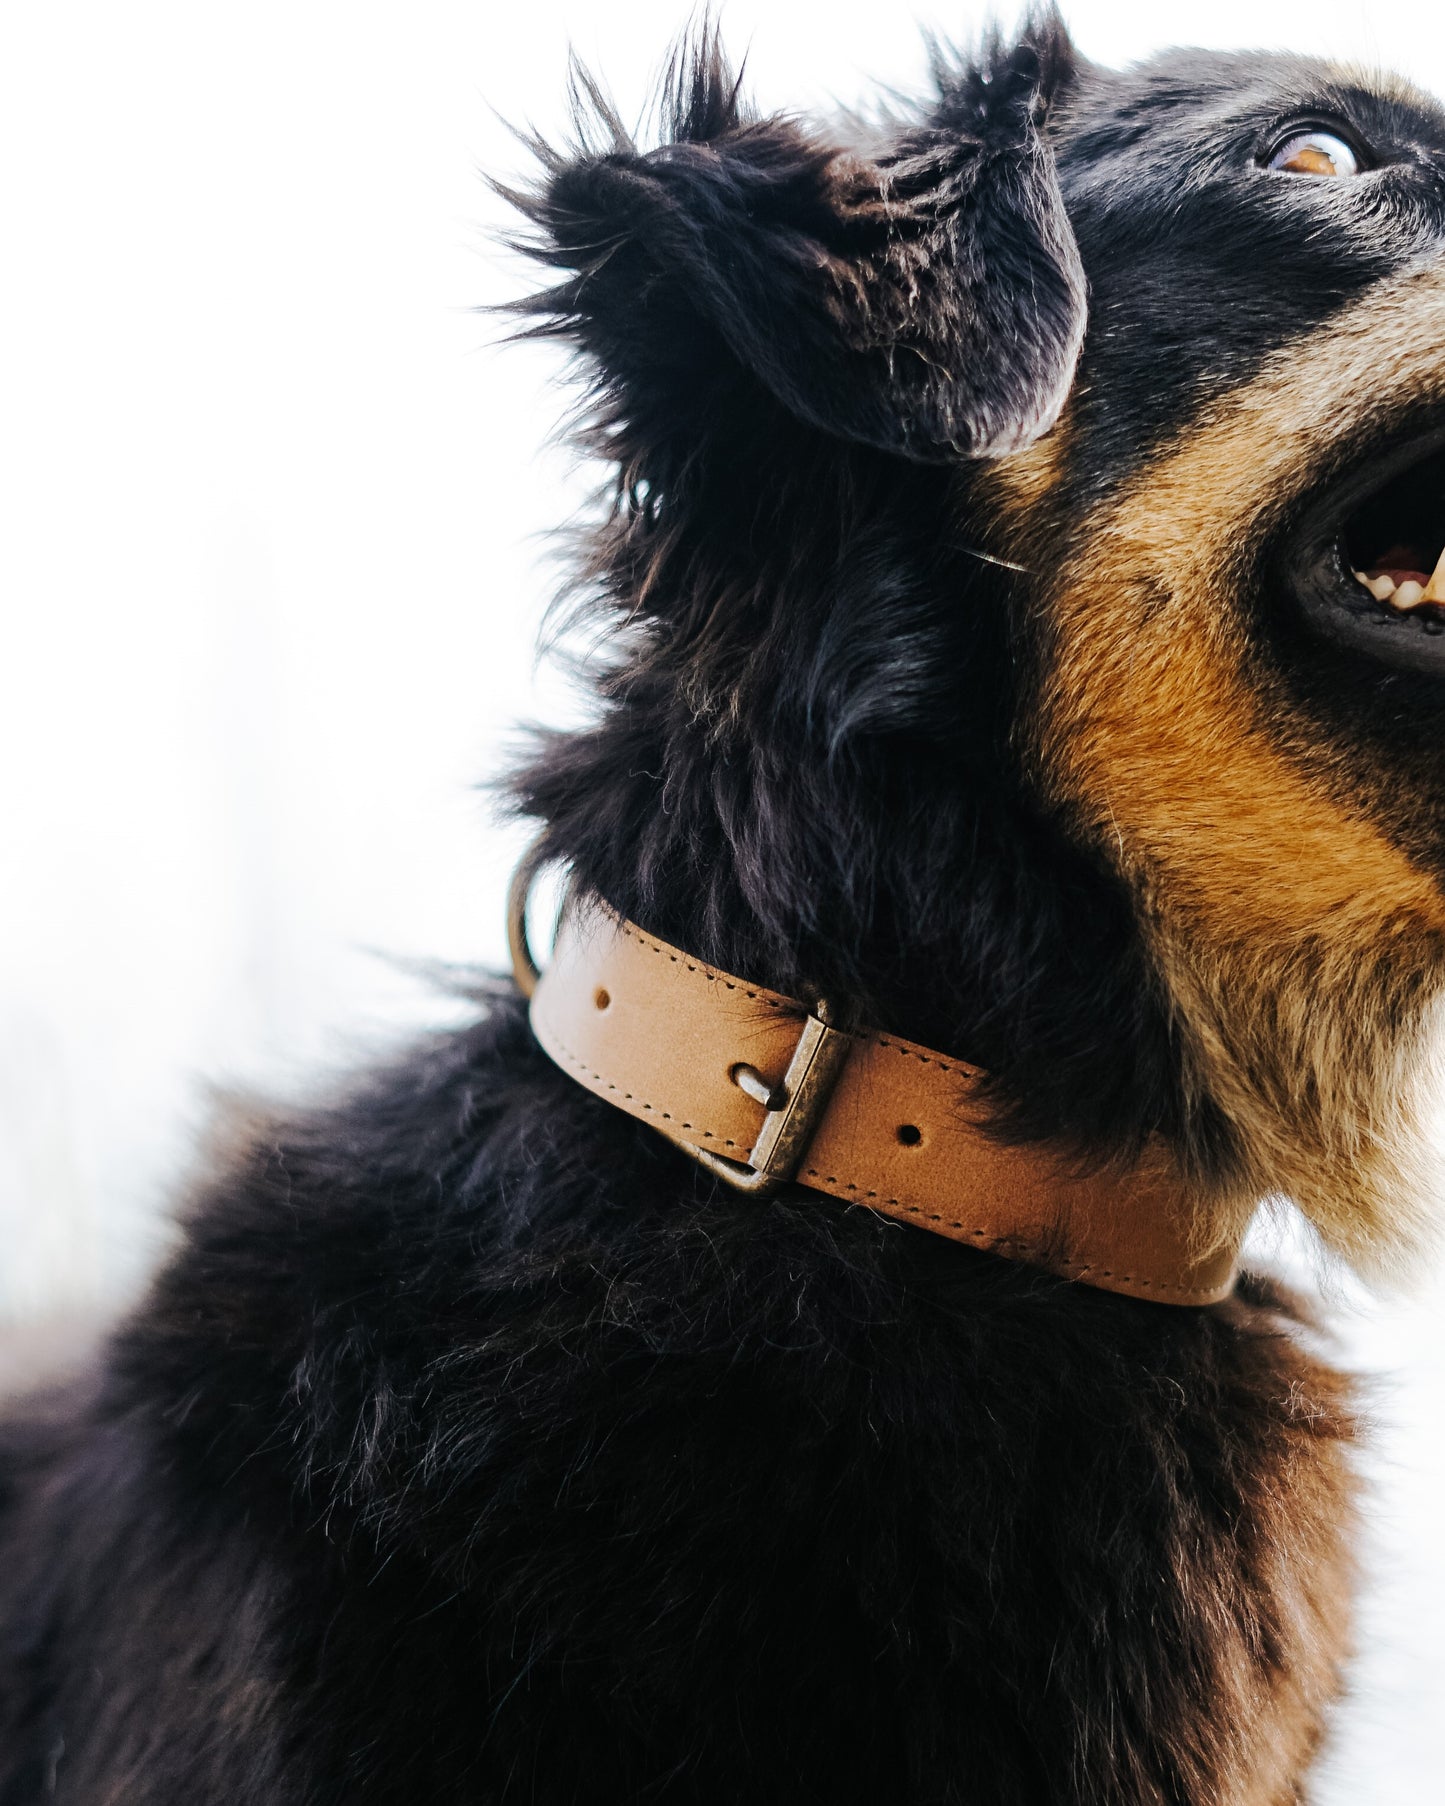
[515,405,1225,1206]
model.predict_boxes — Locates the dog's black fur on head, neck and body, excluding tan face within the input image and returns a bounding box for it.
[11,20,1441,1806]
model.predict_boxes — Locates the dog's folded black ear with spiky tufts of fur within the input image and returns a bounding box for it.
[509,16,1086,461]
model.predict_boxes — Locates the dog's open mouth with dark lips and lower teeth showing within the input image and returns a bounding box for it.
[1288,428,1445,677]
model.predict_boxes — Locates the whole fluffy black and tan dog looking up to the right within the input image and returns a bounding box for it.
[0,20,1445,1806]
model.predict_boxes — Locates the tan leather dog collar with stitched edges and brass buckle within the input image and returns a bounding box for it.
[513,892,1237,1304]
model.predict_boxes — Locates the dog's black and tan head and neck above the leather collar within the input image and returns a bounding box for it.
[509,18,1445,1255]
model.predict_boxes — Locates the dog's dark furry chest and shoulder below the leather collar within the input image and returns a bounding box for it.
[0,1006,1349,1806]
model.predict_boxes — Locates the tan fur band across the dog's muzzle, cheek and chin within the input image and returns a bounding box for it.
[997,264,1445,1266]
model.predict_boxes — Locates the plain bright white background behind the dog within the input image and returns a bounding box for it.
[0,0,1445,1806]
